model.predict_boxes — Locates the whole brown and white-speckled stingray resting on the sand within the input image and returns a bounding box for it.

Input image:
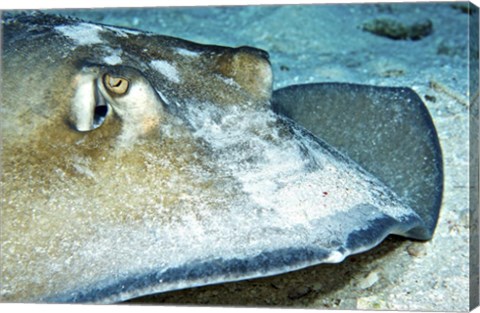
[0,12,443,303]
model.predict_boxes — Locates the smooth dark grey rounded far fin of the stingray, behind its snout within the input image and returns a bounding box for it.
[273,83,443,240]
